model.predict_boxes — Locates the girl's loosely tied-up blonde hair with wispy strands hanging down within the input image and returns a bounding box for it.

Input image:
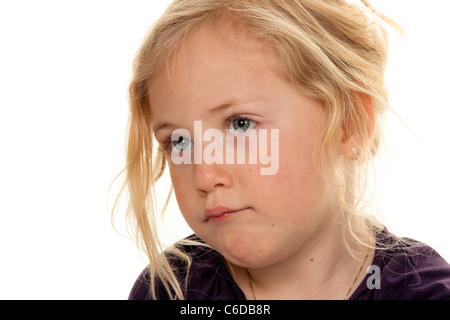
[118,0,402,299]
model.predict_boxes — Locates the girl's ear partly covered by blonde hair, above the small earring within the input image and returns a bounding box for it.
[341,92,376,160]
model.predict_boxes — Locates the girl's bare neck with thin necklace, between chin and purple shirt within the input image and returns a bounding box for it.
[231,215,372,300]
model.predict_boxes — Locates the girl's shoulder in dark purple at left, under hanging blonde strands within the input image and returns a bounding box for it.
[129,235,244,300]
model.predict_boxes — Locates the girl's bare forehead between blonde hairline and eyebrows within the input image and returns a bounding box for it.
[149,21,277,112]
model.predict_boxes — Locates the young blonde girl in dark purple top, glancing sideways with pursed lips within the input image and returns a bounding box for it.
[121,0,450,299]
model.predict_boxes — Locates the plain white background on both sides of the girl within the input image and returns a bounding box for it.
[0,0,450,299]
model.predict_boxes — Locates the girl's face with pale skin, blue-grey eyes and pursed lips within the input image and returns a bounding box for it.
[149,26,336,268]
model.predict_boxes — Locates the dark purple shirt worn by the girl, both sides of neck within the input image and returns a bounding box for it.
[129,231,450,300]
